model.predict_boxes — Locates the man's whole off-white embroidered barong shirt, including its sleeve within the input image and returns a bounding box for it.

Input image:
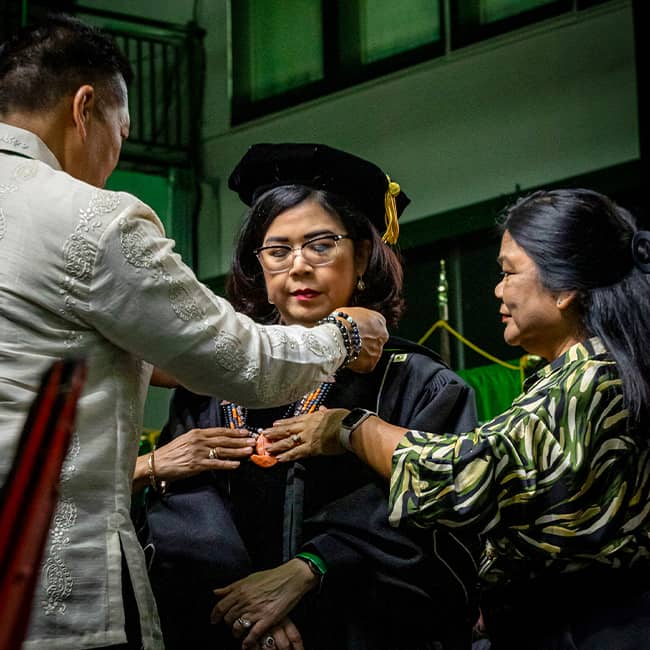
[0,124,345,650]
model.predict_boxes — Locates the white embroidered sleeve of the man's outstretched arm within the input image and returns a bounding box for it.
[82,204,345,407]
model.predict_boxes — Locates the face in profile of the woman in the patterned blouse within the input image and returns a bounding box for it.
[494,230,578,361]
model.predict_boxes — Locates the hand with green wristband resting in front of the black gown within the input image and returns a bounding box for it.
[211,559,318,649]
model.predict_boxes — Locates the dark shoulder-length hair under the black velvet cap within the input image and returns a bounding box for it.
[226,185,404,327]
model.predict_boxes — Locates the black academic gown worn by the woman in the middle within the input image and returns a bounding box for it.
[143,337,478,650]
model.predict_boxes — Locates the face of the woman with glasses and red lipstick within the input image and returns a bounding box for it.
[262,200,368,326]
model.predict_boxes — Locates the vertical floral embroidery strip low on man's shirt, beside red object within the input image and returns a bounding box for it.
[42,431,81,616]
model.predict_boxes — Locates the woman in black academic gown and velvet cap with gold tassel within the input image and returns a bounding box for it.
[139,144,477,650]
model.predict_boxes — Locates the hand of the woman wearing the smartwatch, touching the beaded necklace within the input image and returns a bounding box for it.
[264,406,349,462]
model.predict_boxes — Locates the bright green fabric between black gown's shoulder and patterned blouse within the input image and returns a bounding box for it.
[456,359,521,422]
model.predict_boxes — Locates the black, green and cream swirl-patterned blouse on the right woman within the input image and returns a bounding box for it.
[389,338,650,589]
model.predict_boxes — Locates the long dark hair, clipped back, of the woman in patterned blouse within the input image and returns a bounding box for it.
[500,189,650,425]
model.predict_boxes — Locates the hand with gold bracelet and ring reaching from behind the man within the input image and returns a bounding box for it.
[133,427,255,490]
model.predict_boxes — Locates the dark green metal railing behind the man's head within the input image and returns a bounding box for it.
[0,0,204,169]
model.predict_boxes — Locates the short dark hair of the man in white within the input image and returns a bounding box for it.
[0,14,133,115]
